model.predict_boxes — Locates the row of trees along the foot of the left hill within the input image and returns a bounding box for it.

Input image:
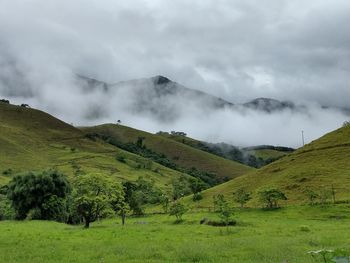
[0,170,204,228]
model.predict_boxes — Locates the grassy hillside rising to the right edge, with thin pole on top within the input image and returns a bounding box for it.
[191,127,350,206]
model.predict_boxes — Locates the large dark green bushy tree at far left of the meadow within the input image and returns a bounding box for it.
[7,170,71,221]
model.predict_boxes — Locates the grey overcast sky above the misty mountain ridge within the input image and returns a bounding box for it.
[0,0,350,146]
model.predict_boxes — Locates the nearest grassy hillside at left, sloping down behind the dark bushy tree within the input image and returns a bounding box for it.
[0,103,190,190]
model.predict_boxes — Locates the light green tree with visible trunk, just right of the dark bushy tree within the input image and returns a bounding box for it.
[74,174,124,228]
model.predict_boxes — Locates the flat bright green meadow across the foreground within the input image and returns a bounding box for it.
[0,205,350,263]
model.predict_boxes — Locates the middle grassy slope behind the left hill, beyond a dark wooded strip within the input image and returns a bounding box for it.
[82,124,253,183]
